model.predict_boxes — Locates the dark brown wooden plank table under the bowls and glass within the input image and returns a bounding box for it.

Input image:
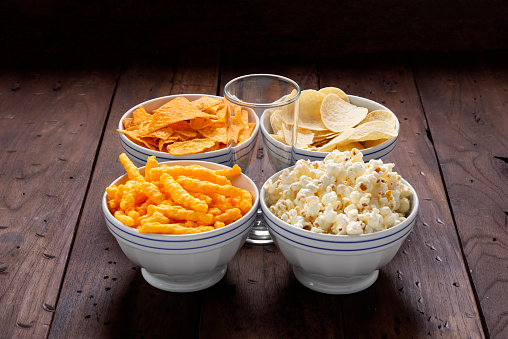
[0,51,508,338]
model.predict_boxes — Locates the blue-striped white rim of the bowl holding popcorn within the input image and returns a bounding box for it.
[259,165,420,244]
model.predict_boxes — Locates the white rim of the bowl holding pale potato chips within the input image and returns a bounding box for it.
[259,95,400,158]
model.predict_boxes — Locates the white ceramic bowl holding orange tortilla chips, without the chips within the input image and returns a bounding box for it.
[118,94,259,168]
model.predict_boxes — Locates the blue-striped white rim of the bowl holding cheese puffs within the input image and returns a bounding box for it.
[101,160,259,242]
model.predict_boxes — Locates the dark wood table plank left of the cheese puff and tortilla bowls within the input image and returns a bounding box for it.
[50,53,218,338]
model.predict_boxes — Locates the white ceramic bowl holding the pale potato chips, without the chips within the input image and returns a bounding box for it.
[261,95,400,170]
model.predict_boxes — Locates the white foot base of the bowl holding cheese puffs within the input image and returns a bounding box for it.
[141,265,228,292]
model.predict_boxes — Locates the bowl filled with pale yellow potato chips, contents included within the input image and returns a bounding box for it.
[261,87,400,169]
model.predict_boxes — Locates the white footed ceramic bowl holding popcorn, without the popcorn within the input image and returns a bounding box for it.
[260,172,418,294]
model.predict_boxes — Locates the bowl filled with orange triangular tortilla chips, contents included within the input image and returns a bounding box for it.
[117,94,259,166]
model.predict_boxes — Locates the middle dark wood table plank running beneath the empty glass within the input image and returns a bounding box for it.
[200,53,342,338]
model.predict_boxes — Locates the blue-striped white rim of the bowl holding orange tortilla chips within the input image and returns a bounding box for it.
[118,93,260,161]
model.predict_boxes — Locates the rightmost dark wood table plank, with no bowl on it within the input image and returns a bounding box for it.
[415,53,508,338]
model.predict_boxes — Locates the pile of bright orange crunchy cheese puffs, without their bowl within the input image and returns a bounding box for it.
[106,153,252,234]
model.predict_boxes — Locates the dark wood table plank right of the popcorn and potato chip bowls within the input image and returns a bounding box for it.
[318,55,484,338]
